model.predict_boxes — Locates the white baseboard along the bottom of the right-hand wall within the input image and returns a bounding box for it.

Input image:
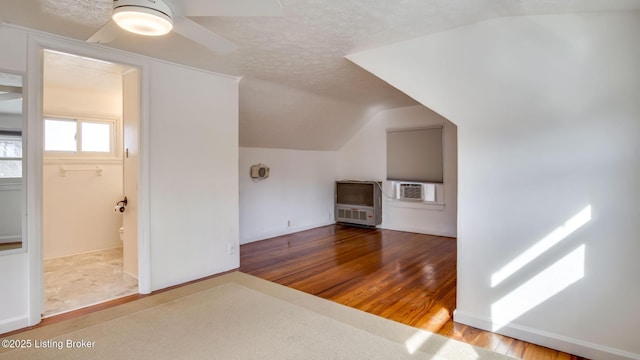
[453,310,640,360]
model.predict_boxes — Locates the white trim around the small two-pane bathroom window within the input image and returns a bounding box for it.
[43,113,122,160]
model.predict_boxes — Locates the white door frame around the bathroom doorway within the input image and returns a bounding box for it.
[25,33,151,326]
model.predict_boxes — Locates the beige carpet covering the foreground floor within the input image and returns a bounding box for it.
[0,272,509,360]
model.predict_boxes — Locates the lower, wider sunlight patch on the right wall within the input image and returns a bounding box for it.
[491,244,585,331]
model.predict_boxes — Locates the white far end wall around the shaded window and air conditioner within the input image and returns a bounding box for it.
[338,106,458,237]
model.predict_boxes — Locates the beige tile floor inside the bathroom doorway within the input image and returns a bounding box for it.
[44,248,138,317]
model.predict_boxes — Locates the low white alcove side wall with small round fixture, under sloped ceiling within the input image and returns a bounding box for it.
[239,147,338,244]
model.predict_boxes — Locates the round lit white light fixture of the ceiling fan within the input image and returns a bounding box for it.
[112,0,173,36]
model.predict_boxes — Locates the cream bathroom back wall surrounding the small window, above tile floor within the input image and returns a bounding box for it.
[42,84,122,259]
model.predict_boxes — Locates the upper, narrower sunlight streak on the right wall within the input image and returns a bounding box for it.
[491,205,591,287]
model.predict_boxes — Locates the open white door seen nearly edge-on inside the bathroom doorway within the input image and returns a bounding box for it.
[122,69,140,279]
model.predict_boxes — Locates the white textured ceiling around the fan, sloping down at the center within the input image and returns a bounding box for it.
[0,0,640,150]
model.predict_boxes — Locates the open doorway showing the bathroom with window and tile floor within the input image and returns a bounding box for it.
[42,50,140,317]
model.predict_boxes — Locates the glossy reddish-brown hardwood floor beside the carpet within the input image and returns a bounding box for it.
[240,225,585,360]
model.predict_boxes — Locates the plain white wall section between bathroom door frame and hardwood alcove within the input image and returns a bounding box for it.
[149,61,240,290]
